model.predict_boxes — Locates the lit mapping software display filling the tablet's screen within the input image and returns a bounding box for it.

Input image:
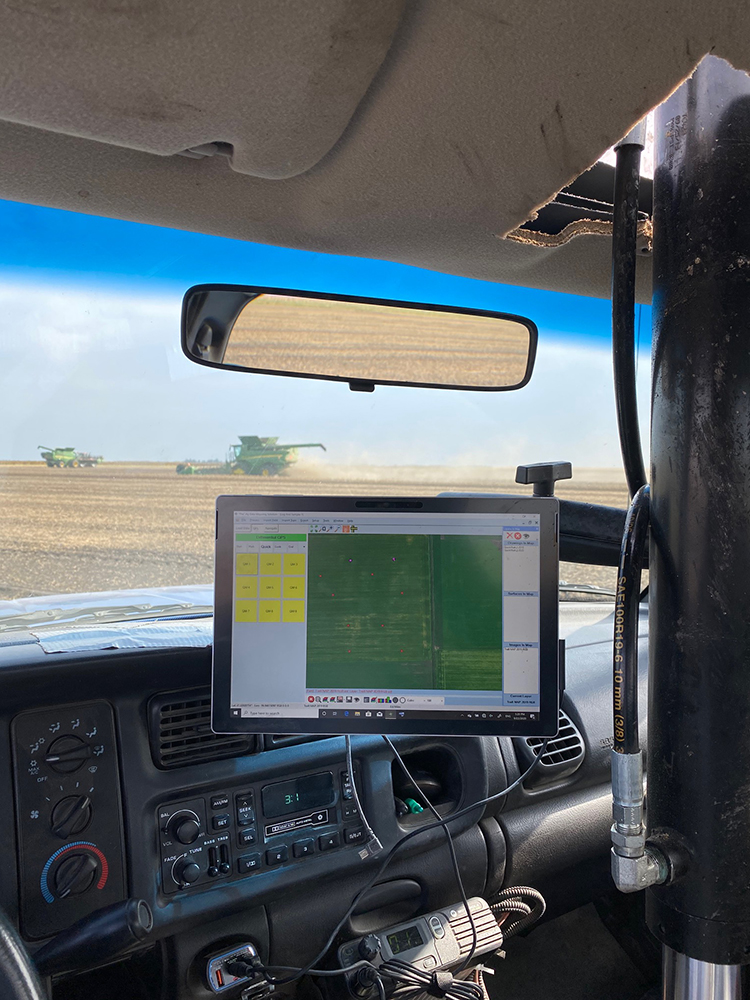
[231,511,539,719]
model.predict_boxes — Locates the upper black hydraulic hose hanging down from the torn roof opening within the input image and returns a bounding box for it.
[612,141,646,497]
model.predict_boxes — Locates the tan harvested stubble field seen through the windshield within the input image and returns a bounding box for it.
[0,462,627,600]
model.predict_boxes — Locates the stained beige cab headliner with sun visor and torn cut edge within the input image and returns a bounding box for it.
[0,0,750,298]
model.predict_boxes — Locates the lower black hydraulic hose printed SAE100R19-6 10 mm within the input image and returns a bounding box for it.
[613,485,651,753]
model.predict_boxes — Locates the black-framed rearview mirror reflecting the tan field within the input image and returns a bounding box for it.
[182,285,538,392]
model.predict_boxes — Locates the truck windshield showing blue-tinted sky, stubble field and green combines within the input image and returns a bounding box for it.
[0,202,650,617]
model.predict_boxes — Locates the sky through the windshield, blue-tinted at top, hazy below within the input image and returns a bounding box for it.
[0,201,651,466]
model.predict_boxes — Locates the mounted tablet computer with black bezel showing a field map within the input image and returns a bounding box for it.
[212,496,559,736]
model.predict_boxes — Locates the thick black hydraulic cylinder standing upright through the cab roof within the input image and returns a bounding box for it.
[646,56,750,965]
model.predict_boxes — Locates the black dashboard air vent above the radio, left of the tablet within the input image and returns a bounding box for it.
[149,688,257,769]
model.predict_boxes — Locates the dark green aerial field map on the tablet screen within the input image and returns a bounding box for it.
[307,534,503,691]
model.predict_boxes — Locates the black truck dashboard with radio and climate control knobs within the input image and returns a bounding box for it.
[0,603,647,998]
